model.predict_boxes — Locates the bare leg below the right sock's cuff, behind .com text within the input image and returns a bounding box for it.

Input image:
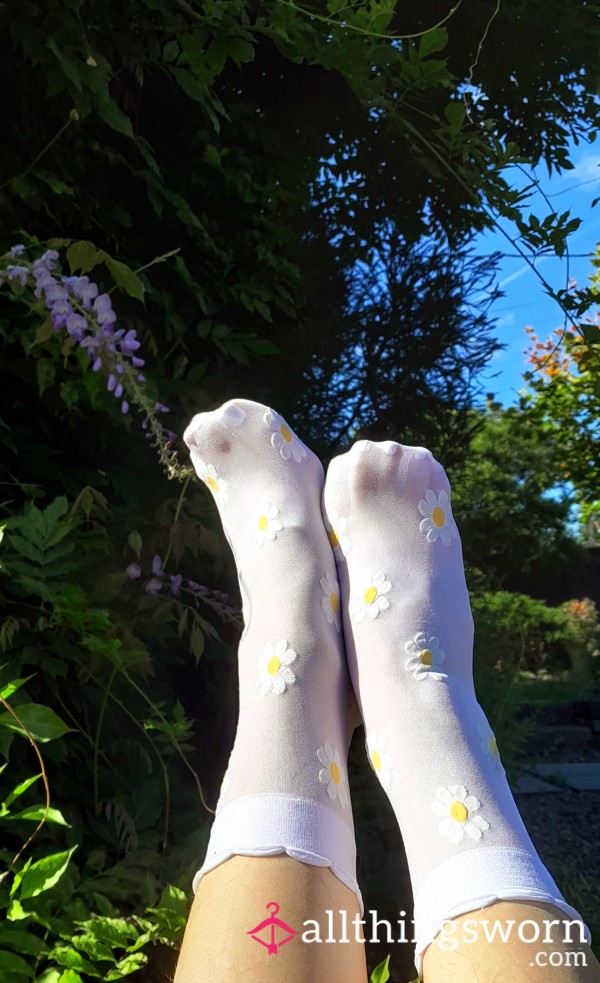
[423,901,600,983]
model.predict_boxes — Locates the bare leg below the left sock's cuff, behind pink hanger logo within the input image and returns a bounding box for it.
[175,855,367,983]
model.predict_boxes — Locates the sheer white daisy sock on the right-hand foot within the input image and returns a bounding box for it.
[323,441,580,973]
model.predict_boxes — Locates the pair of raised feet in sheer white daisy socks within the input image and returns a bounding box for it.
[184,399,579,966]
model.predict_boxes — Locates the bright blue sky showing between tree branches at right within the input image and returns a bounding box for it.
[474,144,600,406]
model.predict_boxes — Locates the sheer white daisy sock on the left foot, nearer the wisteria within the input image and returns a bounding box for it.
[184,399,360,903]
